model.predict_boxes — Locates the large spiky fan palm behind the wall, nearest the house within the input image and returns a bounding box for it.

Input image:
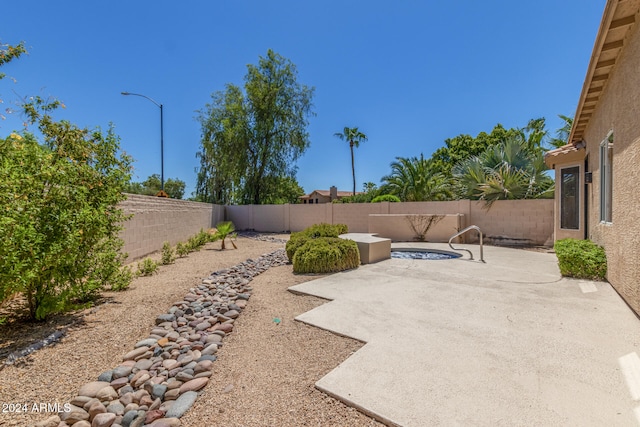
[453,138,554,206]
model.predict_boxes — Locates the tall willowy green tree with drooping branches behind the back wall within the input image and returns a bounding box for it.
[196,50,314,204]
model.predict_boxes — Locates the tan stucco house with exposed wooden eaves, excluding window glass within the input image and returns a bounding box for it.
[546,0,640,313]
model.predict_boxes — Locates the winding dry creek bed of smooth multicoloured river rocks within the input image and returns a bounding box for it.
[36,249,288,427]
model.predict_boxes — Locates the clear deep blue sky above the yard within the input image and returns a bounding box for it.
[0,0,605,197]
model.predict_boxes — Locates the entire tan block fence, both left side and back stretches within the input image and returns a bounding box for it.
[121,194,553,261]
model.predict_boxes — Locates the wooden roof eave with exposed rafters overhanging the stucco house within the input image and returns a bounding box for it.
[568,0,640,144]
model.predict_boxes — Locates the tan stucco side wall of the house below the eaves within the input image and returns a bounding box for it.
[585,17,640,313]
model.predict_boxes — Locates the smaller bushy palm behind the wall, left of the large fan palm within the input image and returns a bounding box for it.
[382,154,452,202]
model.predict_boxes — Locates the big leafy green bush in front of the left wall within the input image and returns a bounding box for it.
[0,97,131,320]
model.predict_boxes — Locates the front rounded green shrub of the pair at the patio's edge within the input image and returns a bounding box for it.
[293,237,360,273]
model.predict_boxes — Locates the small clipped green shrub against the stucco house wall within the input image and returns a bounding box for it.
[554,239,607,280]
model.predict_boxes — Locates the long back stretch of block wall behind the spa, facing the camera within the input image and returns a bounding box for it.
[225,199,553,246]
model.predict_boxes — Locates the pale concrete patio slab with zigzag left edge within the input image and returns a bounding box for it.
[291,244,640,426]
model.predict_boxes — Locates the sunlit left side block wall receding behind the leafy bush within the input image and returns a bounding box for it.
[120,194,224,261]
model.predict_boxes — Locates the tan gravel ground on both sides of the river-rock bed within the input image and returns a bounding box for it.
[0,237,380,427]
